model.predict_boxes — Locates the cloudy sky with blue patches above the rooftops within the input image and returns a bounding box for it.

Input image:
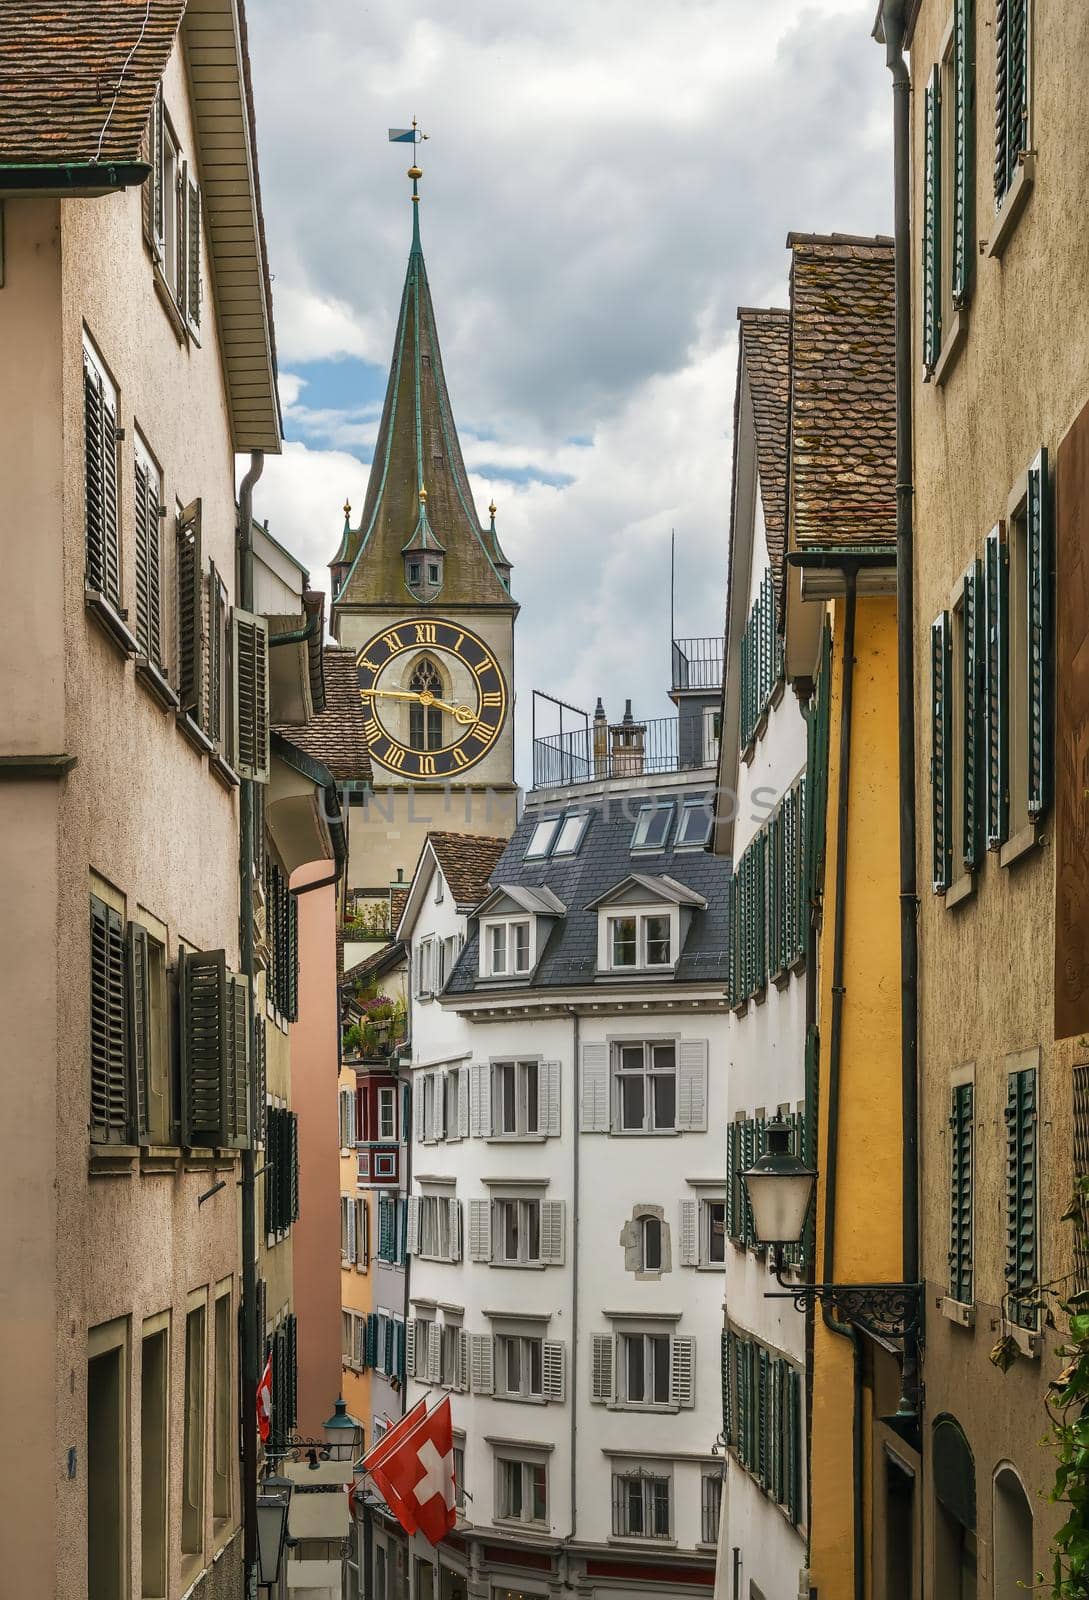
[248,0,892,781]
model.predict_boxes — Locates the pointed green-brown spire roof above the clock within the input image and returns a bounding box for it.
[333,166,512,613]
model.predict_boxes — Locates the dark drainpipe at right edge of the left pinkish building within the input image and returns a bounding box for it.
[238,450,265,1600]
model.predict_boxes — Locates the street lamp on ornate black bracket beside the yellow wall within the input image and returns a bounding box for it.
[740,1122,923,1339]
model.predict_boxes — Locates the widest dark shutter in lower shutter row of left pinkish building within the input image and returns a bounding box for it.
[179,950,229,1147]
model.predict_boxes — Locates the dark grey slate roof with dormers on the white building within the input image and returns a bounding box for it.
[445,789,731,994]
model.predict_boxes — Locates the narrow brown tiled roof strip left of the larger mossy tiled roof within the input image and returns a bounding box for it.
[737,306,790,582]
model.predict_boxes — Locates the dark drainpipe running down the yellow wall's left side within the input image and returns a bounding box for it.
[820,565,865,1600]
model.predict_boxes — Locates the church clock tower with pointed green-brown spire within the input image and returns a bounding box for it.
[329,165,518,899]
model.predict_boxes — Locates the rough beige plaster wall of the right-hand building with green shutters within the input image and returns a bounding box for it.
[911,0,1089,1576]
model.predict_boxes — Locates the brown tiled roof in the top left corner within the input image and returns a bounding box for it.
[0,0,185,166]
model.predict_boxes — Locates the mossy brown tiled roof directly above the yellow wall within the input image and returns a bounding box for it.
[787,234,896,550]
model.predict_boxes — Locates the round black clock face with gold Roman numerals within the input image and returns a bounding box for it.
[355,618,507,779]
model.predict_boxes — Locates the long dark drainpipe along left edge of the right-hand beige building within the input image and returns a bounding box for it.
[881,0,919,1419]
